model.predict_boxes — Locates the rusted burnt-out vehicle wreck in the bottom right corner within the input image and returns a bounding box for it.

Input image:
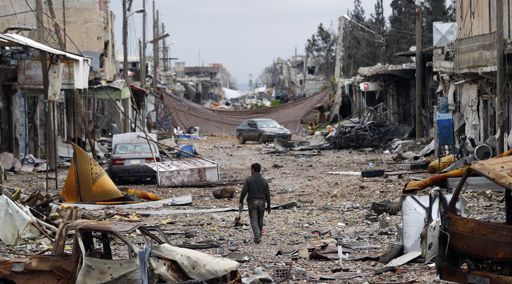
[436,157,512,283]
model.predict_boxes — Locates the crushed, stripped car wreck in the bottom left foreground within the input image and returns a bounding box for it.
[0,220,241,283]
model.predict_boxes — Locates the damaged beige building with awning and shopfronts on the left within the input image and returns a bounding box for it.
[0,0,116,160]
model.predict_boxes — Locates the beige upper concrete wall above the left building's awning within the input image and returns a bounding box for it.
[0,0,116,80]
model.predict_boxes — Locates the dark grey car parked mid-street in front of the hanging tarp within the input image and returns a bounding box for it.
[236,118,292,144]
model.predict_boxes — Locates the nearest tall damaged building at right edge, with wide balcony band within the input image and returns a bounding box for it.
[433,0,512,146]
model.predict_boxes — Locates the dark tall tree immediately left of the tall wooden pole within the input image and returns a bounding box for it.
[386,0,416,64]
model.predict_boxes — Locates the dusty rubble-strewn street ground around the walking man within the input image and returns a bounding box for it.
[3,137,448,283]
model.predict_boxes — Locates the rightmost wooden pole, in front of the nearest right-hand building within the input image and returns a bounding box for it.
[496,0,507,154]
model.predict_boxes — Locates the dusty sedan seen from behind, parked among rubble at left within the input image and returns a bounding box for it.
[108,143,160,181]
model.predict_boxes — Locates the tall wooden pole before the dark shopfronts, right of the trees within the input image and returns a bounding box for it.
[416,4,423,139]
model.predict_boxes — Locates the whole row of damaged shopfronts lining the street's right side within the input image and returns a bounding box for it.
[352,0,512,145]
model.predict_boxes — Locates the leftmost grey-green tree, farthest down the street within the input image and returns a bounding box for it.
[306,24,337,79]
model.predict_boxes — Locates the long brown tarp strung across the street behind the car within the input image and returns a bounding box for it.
[163,93,327,135]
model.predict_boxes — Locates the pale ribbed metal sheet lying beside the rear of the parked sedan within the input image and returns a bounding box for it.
[146,158,219,187]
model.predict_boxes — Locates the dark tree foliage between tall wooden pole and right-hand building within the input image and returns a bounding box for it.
[423,0,450,46]
